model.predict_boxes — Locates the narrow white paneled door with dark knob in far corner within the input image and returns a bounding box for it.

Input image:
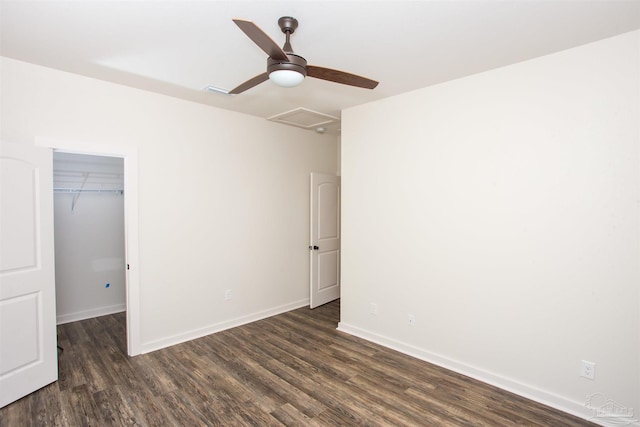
[309,172,340,308]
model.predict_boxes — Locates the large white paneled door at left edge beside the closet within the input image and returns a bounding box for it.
[0,142,58,407]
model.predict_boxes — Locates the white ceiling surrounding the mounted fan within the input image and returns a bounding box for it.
[0,0,640,132]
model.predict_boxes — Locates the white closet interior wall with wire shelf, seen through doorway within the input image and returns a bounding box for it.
[53,153,126,324]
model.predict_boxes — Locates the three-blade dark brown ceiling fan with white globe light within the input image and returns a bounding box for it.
[229,16,378,95]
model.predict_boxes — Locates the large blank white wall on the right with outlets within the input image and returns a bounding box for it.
[340,32,640,421]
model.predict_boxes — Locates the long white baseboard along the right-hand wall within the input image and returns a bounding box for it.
[338,322,628,426]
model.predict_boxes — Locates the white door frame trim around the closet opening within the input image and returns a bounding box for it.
[35,137,141,356]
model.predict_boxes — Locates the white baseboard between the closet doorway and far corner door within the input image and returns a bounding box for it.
[140,298,309,354]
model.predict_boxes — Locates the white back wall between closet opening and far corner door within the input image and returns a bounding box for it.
[0,58,337,352]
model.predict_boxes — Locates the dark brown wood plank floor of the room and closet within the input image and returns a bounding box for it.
[0,301,594,427]
